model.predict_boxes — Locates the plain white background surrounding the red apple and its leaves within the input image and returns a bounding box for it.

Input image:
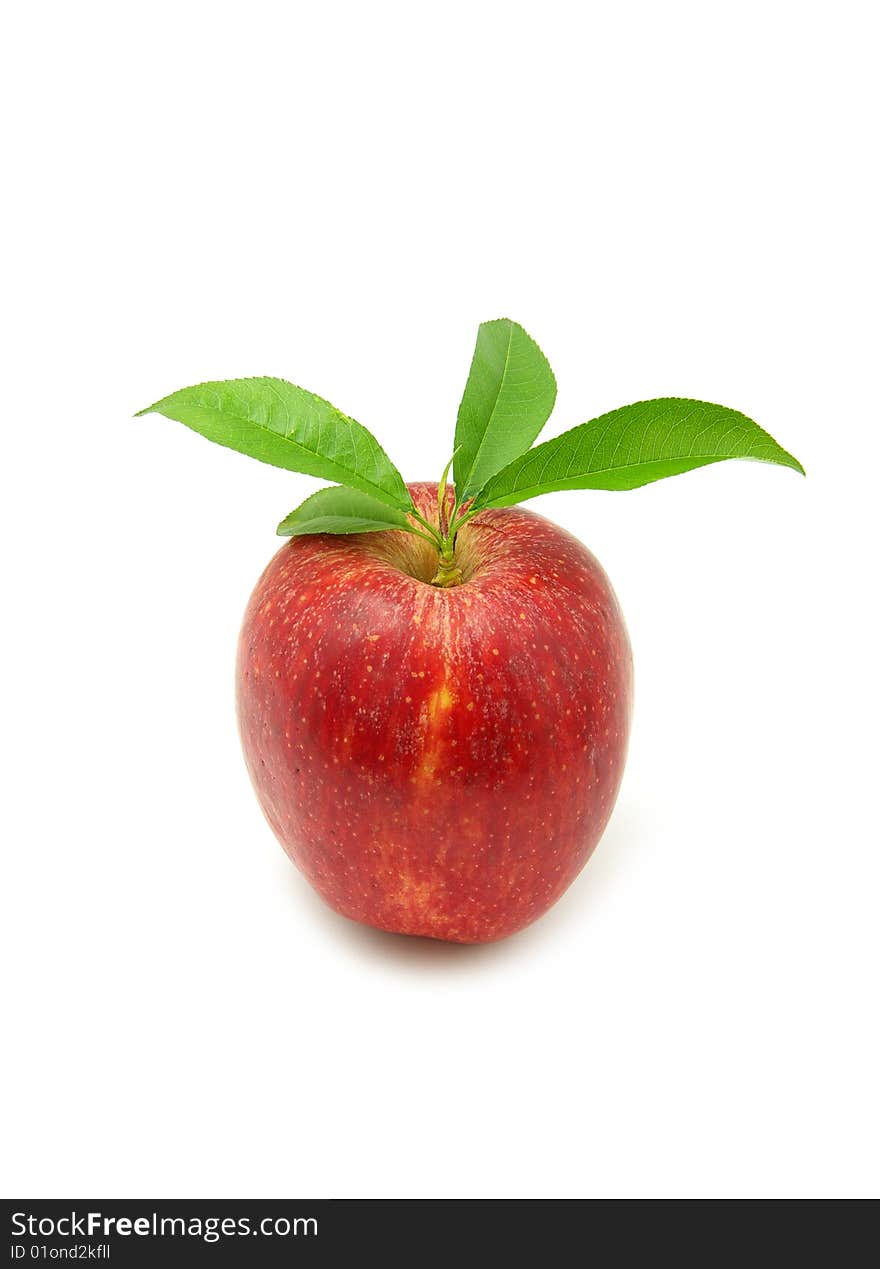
[0,0,880,1197]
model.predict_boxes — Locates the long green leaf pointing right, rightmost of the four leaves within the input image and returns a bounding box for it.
[474,397,804,506]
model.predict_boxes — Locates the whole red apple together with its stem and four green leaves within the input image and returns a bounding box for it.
[140,309,804,943]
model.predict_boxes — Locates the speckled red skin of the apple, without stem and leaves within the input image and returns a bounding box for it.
[237,483,632,943]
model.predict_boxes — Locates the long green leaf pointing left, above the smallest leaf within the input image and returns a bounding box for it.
[138,378,413,509]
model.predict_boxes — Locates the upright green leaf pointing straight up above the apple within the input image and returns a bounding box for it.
[455,317,556,500]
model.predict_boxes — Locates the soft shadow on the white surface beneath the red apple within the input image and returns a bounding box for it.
[281,801,646,973]
